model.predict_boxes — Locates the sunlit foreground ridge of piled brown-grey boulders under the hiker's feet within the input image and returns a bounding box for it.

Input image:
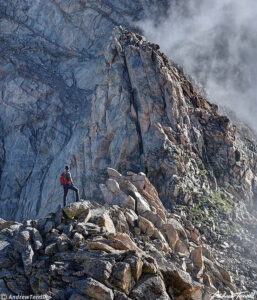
[0,168,240,300]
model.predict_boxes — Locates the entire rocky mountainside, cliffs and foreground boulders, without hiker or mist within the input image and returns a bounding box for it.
[0,0,257,300]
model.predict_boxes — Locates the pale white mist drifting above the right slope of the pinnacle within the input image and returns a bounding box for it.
[138,0,257,133]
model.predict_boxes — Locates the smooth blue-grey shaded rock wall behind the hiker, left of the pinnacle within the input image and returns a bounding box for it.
[0,0,168,220]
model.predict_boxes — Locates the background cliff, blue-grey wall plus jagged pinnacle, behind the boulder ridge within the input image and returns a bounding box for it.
[0,1,257,225]
